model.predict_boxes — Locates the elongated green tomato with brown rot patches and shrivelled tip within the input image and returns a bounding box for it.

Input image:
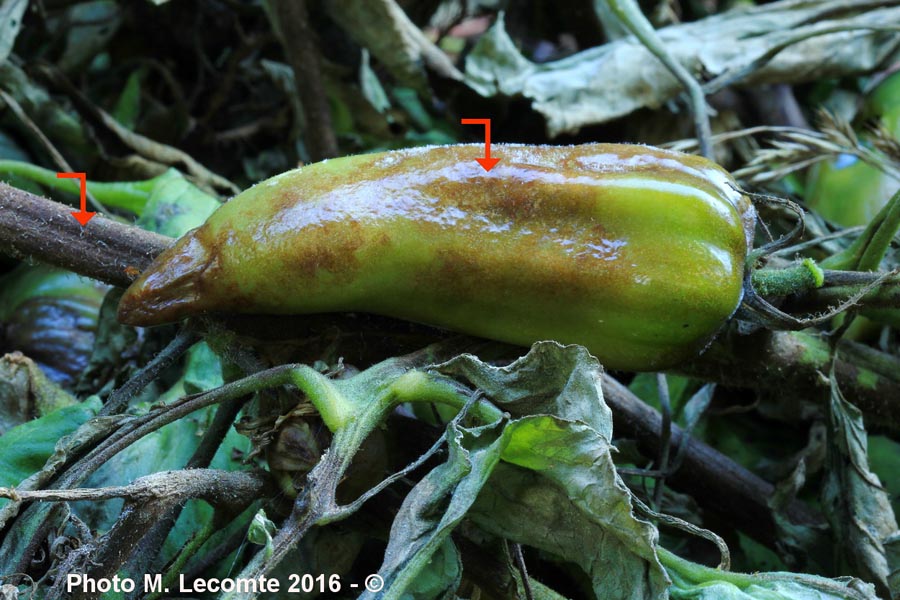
[119,144,755,370]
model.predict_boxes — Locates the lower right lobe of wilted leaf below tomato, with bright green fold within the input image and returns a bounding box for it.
[472,417,668,598]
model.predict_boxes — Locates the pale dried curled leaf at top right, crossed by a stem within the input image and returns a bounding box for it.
[466,0,900,136]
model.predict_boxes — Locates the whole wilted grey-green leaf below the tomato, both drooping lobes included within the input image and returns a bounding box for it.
[364,342,668,598]
